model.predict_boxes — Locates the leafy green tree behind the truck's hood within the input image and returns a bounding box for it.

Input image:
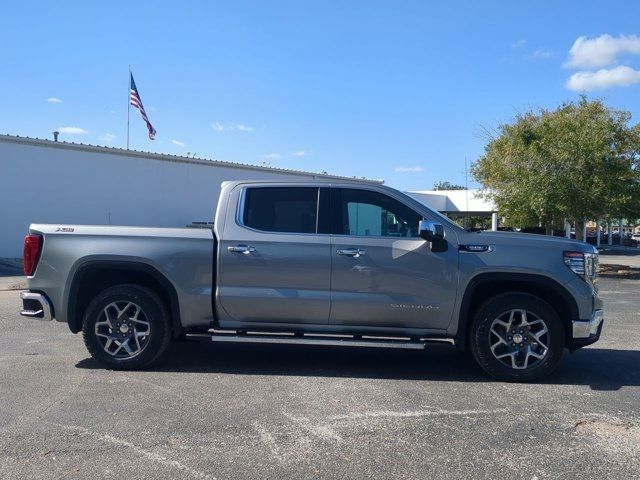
[471,97,640,230]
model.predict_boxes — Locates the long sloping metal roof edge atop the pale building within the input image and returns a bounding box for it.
[0,134,384,183]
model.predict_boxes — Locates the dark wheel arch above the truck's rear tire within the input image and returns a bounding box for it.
[67,260,182,338]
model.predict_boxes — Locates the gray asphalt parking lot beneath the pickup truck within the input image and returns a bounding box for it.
[0,278,640,480]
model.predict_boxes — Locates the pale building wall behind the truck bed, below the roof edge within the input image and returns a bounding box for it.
[0,136,376,258]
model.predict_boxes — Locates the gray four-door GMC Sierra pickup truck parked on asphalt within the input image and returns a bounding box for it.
[21,181,603,381]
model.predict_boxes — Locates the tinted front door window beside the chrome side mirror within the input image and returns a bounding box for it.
[332,189,422,237]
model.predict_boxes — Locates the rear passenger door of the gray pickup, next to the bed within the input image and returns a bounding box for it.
[217,184,331,324]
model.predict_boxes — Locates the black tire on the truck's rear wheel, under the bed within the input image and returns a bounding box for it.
[82,285,171,370]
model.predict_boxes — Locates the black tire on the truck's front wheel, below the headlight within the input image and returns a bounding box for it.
[469,293,565,382]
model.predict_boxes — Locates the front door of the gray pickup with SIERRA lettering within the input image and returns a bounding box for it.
[329,188,458,329]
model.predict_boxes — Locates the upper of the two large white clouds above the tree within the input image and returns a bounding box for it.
[565,34,640,68]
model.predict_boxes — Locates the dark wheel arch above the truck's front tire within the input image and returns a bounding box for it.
[456,272,579,350]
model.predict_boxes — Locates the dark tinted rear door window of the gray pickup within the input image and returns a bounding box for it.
[242,187,318,233]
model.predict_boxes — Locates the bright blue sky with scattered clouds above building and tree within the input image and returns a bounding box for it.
[0,0,640,190]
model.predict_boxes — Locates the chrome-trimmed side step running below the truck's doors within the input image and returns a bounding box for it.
[187,329,453,350]
